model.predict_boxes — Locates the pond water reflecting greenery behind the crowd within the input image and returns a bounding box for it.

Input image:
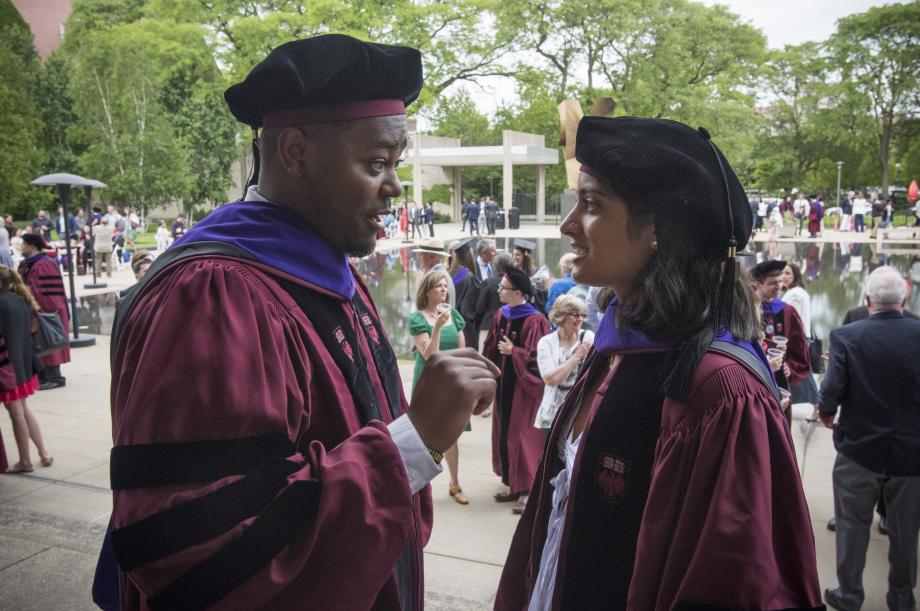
[78,238,920,358]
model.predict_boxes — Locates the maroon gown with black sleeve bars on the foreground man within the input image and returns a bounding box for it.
[111,255,432,611]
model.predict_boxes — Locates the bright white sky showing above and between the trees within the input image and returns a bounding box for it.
[452,0,897,123]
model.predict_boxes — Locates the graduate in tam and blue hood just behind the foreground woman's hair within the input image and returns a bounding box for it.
[751,260,811,400]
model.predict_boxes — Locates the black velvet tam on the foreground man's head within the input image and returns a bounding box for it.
[224,34,422,128]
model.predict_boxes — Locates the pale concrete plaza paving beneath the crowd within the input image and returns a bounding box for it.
[0,225,916,611]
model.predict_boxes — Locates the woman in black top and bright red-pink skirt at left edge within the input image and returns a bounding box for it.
[0,265,54,473]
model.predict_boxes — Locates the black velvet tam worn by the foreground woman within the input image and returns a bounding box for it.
[575,117,753,252]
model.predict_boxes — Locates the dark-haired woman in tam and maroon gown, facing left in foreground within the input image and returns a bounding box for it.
[495,117,821,611]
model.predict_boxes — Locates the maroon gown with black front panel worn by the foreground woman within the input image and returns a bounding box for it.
[495,352,822,611]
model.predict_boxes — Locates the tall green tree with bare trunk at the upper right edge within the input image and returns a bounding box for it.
[829,0,920,194]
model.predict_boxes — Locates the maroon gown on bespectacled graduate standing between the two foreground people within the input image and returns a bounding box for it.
[482,308,550,492]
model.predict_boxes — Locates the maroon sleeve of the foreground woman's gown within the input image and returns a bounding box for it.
[628,364,821,611]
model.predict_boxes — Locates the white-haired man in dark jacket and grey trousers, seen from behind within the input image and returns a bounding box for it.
[820,266,920,609]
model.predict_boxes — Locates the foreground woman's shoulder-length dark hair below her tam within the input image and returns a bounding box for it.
[598,189,760,400]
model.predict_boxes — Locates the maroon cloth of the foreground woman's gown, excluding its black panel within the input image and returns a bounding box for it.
[495,352,821,611]
